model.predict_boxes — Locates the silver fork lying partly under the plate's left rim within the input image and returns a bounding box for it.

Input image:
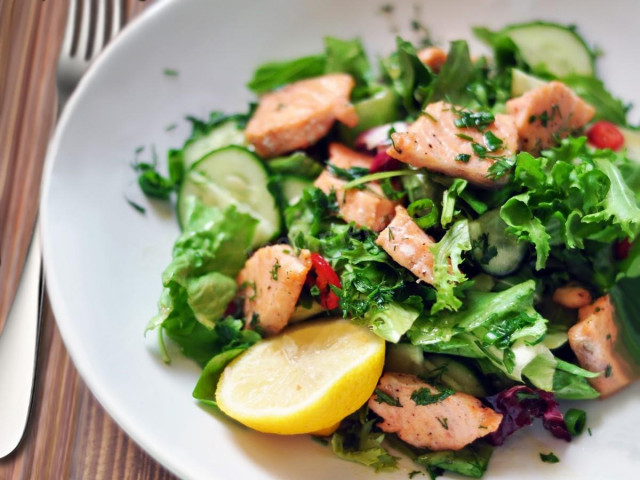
[0,0,124,458]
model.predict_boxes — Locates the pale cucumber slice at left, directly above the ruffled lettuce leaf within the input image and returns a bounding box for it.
[178,146,282,246]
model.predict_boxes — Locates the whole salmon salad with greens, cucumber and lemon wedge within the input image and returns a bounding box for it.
[134,22,640,478]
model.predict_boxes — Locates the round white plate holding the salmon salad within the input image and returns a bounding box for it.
[41,0,640,480]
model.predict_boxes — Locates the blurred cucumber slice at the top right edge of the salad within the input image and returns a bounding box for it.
[500,22,595,78]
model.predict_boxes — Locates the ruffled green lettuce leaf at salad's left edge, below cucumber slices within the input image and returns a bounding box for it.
[148,202,257,364]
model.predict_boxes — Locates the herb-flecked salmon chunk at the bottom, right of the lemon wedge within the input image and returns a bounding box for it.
[369,373,502,451]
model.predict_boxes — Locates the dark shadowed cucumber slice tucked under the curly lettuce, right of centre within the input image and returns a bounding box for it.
[469,209,528,276]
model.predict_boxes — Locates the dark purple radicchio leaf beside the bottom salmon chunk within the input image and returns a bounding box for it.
[486,385,571,446]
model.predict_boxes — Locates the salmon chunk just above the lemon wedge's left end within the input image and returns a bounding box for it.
[236,245,311,335]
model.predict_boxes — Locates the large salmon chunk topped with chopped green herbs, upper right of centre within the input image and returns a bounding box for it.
[387,102,518,188]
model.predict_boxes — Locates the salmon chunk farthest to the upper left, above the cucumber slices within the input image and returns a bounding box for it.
[245,73,358,158]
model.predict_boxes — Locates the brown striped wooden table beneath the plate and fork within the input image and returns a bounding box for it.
[0,0,175,480]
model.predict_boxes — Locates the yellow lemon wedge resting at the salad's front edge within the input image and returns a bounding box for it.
[216,319,385,435]
